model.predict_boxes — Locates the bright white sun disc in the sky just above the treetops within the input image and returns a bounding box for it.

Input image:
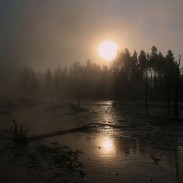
[98,41,118,61]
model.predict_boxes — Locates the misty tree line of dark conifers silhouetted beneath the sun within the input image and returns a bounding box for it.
[18,46,183,109]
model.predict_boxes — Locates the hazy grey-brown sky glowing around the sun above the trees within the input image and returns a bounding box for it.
[0,0,183,70]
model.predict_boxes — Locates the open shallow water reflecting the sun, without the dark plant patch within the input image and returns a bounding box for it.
[1,101,183,183]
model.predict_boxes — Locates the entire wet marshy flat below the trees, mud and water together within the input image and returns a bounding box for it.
[0,101,183,183]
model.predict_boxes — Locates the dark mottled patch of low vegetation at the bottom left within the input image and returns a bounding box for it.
[0,142,86,182]
